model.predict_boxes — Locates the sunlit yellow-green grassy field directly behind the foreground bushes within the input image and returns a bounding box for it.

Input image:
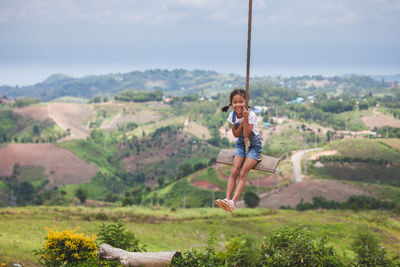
[0,206,400,266]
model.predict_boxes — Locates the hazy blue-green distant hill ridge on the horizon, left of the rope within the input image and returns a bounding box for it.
[0,69,243,101]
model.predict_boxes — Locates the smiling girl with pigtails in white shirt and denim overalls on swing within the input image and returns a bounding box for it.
[215,89,261,213]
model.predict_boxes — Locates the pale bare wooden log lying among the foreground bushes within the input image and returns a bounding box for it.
[97,244,181,267]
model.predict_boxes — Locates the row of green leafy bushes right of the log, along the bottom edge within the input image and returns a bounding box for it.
[171,227,400,267]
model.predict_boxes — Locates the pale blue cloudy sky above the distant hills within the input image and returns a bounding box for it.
[0,0,400,85]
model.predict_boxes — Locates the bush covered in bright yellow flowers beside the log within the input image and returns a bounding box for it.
[35,230,97,266]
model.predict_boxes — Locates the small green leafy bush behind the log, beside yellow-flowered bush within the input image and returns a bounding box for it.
[98,222,146,252]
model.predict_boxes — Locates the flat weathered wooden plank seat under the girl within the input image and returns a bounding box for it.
[217,149,280,173]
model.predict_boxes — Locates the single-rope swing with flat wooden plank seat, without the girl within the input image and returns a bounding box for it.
[216,0,280,173]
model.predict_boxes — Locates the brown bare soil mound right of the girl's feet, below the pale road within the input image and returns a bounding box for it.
[260,179,371,209]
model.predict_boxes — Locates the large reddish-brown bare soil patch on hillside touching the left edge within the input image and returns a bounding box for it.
[0,144,98,189]
